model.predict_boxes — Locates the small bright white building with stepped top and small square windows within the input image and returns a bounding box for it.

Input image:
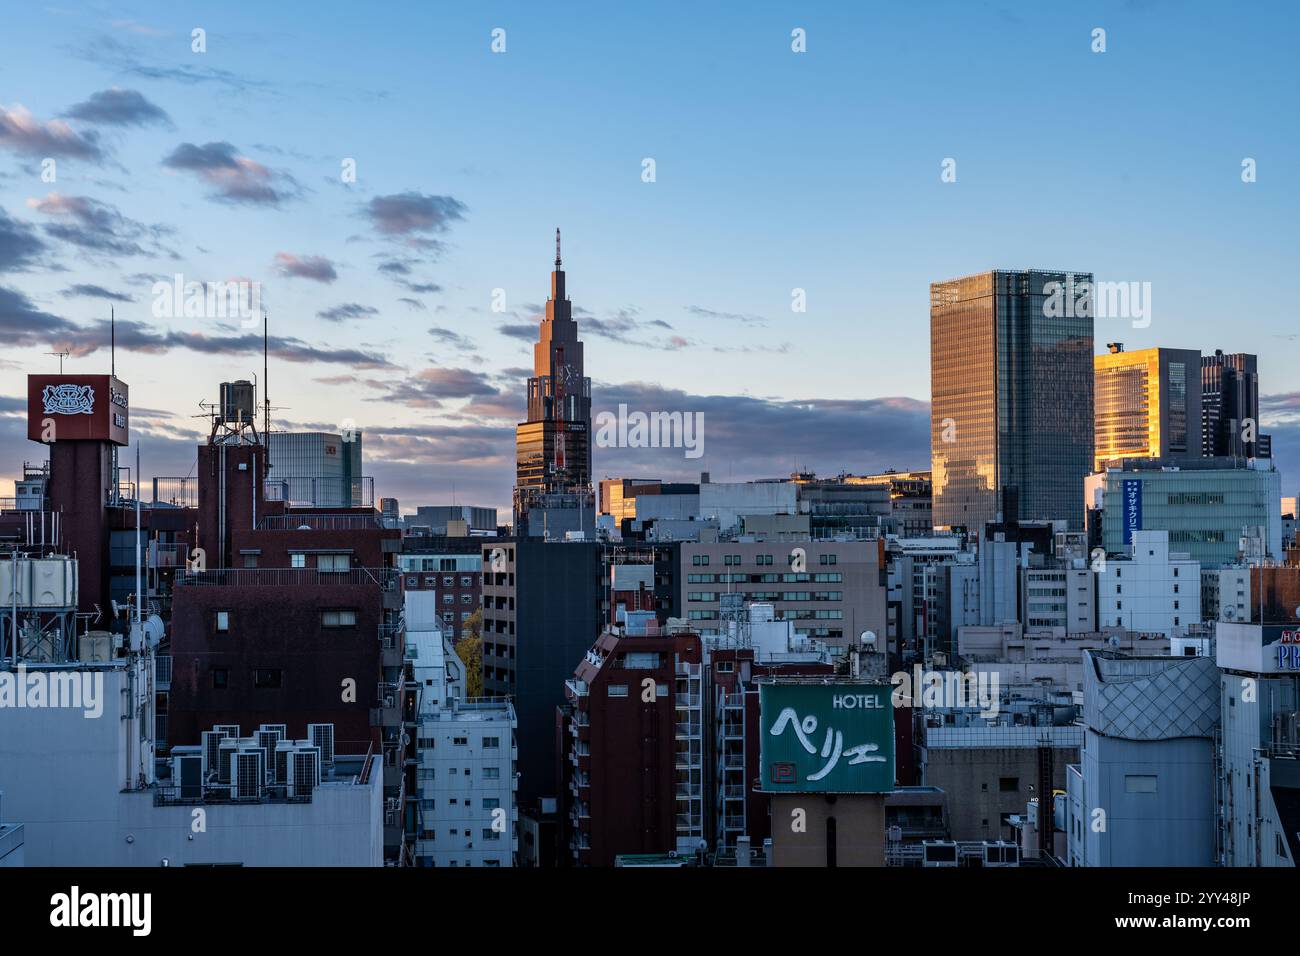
[1097,531,1201,637]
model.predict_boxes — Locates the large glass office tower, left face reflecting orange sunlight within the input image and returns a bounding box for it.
[930,269,1093,531]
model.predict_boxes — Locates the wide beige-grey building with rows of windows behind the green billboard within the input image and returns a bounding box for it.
[677,538,888,653]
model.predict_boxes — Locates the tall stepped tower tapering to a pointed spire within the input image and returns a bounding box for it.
[515,229,594,536]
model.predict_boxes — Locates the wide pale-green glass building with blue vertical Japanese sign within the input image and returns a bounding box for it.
[1093,458,1283,567]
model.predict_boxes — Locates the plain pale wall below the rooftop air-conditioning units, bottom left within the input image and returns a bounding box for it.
[0,667,384,866]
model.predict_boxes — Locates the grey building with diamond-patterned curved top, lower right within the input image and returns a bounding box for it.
[1066,652,1219,866]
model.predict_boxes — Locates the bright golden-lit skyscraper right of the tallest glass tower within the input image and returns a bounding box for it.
[1093,342,1201,471]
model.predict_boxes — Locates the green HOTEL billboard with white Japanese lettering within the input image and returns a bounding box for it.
[758,683,894,793]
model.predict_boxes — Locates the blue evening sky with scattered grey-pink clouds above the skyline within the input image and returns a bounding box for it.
[0,0,1300,518]
